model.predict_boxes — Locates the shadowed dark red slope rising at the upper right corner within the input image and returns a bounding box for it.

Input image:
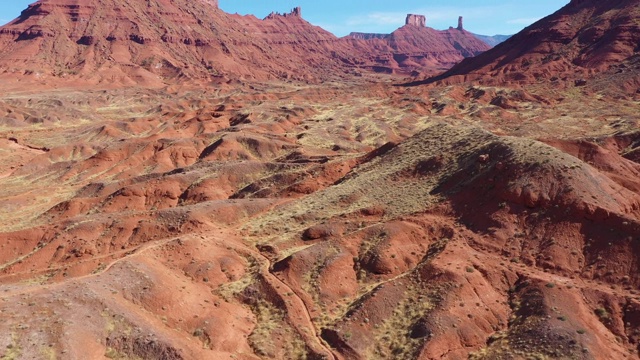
[430,0,640,87]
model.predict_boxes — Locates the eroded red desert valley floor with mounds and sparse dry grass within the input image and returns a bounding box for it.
[0,77,640,359]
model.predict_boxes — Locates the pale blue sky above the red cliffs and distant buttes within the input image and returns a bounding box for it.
[0,0,568,36]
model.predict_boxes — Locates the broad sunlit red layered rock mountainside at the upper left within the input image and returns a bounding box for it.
[0,0,353,84]
